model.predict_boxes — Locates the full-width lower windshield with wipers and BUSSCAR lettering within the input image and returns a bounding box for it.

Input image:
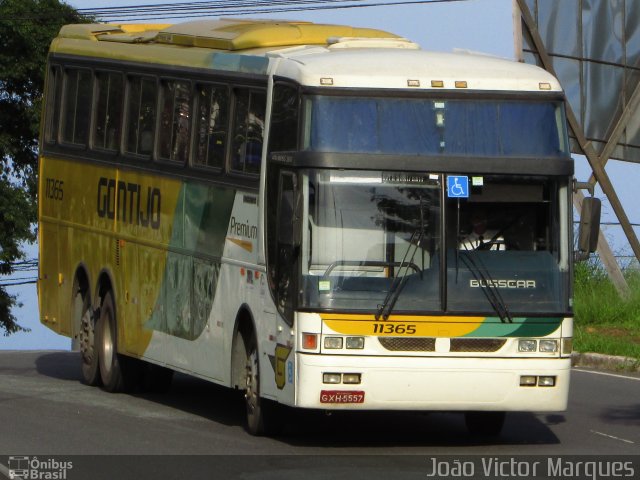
[301,170,569,316]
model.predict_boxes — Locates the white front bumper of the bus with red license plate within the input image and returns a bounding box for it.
[295,353,571,412]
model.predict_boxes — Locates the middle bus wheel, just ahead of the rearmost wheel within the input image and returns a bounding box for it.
[96,292,141,393]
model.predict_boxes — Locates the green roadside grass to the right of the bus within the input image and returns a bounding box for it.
[573,262,640,359]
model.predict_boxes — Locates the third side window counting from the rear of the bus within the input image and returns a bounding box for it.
[93,72,124,151]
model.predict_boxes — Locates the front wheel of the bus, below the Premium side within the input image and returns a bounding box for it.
[244,336,283,436]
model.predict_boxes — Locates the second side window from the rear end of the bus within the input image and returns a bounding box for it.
[62,68,93,146]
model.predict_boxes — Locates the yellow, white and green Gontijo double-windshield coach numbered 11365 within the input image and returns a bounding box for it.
[38,20,573,434]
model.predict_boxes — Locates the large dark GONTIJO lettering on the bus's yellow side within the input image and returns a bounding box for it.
[97,177,162,230]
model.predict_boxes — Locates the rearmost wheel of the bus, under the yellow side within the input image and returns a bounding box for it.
[73,291,101,387]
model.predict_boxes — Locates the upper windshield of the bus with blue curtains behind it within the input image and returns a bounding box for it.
[304,95,568,157]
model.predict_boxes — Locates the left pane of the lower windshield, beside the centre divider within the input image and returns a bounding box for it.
[302,171,441,311]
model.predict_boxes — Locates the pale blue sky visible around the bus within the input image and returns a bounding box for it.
[0,0,640,350]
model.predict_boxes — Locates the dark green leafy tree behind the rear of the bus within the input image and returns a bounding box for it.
[0,0,92,335]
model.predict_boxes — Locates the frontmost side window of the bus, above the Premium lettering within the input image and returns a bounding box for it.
[231,88,267,174]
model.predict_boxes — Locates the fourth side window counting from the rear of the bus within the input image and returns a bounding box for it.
[126,77,158,156]
